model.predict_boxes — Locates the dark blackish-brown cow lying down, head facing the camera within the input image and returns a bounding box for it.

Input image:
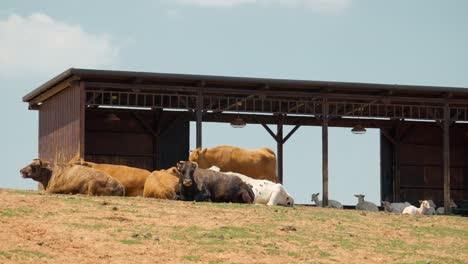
[177,161,254,204]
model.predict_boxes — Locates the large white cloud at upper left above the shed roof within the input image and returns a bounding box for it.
[0,13,119,77]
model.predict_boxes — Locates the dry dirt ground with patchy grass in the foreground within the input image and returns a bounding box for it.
[0,189,468,263]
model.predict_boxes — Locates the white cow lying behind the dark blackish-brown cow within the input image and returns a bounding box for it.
[209,166,294,207]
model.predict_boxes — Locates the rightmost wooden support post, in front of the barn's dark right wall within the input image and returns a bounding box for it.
[443,105,451,214]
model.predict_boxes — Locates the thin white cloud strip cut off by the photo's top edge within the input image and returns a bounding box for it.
[176,0,351,12]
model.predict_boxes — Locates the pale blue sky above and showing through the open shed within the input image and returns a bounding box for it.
[0,0,468,204]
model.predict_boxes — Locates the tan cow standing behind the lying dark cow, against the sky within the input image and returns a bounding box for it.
[189,146,277,182]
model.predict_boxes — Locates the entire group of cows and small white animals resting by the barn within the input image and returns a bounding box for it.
[20,146,456,214]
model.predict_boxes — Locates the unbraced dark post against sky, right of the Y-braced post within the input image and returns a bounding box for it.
[322,98,328,207]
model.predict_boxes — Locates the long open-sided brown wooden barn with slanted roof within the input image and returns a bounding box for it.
[23,69,468,211]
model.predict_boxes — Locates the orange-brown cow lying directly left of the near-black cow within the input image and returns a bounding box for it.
[143,167,179,199]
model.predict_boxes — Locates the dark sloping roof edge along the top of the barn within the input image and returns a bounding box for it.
[23,68,468,103]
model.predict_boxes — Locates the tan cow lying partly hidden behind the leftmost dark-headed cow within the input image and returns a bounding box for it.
[81,161,151,196]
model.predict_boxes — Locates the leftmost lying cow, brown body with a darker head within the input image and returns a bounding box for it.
[20,159,125,196]
